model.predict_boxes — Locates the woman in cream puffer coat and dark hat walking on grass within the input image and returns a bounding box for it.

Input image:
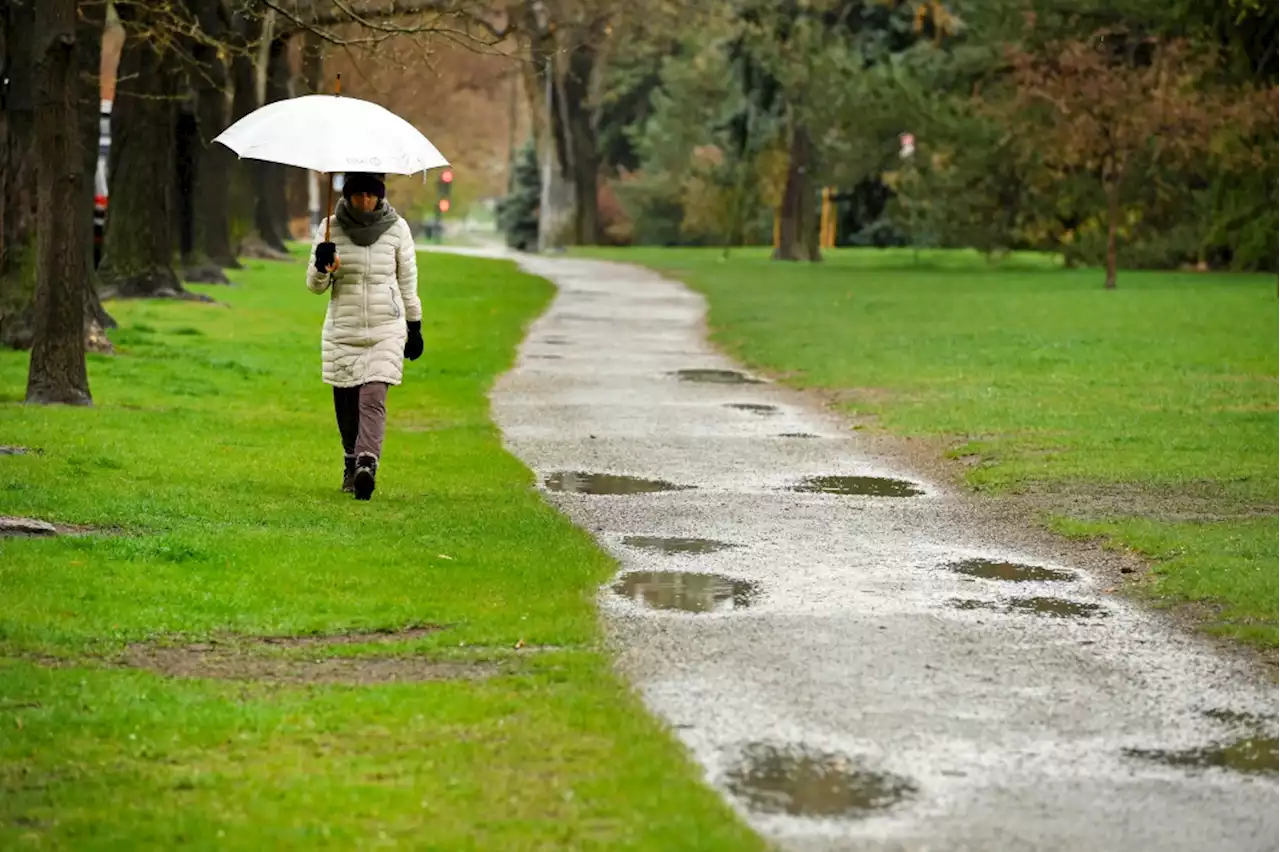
[307,171,422,500]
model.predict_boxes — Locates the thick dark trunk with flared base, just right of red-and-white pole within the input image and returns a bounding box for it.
[99,5,183,298]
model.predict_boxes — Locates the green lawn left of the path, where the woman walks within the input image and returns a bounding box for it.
[0,256,762,851]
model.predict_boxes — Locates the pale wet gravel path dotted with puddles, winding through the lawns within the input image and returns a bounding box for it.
[465,249,1280,852]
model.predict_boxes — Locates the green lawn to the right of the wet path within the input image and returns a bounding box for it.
[578,249,1280,646]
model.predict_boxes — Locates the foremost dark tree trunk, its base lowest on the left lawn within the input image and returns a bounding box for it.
[27,0,92,406]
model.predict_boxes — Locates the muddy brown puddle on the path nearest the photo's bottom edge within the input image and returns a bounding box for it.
[726,743,918,817]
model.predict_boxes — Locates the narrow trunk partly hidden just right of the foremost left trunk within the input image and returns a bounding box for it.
[76,3,115,354]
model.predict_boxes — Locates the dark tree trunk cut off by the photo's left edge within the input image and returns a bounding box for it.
[0,3,37,349]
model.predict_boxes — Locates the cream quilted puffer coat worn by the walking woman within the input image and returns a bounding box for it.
[307,217,422,388]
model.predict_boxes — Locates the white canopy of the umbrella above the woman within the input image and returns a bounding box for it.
[214,95,449,174]
